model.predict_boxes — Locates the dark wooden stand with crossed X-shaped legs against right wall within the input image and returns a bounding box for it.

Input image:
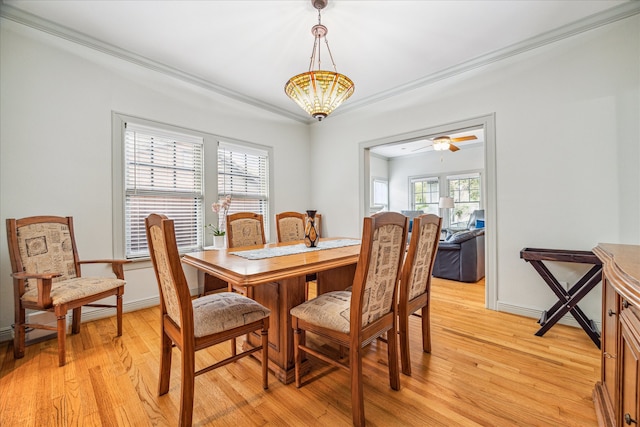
[520,248,602,348]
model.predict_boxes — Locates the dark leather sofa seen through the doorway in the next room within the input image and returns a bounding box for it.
[433,228,485,282]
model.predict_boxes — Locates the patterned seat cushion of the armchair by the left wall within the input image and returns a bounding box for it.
[22,277,127,305]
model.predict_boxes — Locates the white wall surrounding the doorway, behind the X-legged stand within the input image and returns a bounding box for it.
[312,15,640,324]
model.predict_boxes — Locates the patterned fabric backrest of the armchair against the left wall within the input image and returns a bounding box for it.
[17,223,77,292]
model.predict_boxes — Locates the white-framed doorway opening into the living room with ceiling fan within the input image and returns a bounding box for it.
[359,114,498,310]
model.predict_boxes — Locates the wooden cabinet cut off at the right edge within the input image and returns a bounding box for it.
[593,243,640,427]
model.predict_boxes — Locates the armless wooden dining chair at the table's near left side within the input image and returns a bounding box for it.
[145,214,270,427]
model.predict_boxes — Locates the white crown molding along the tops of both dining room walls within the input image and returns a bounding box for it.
[0,0,640,124]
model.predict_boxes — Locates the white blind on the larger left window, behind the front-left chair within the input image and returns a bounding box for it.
[124,123,204,259]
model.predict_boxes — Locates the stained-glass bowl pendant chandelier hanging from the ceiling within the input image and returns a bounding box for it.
[284,0,354,121]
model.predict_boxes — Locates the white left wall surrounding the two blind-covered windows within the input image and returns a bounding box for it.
[0,19,311,339]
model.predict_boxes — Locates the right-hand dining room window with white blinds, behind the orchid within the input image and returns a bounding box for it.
[218,141,270,238]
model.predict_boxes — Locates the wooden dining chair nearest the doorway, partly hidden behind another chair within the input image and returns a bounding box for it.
[398,214,442,375]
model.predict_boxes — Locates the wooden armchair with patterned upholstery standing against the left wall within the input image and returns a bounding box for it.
[7,216,129,366]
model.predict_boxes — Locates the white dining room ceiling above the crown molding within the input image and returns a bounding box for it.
[0,0,640,122]
